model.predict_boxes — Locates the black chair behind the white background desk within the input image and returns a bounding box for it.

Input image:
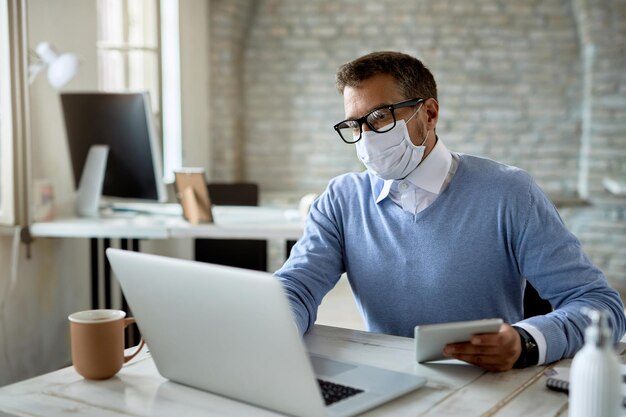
[195,183,267,271]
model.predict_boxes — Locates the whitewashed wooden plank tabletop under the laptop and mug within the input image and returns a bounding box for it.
[0,326,570,417]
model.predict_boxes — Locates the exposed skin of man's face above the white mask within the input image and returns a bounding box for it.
[343,74,434,145]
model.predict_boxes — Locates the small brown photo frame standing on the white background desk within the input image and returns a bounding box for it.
[174,168,213,224]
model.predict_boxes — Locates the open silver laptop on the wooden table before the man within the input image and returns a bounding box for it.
[106,249,426,417]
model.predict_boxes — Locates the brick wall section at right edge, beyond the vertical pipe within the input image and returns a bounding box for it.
[562,0,626,294]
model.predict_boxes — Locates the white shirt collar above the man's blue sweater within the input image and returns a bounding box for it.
[376,139,452,203]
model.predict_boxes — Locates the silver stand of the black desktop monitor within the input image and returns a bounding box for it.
[75,145,109,217]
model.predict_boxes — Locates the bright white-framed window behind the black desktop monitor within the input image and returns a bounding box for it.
[97,0,182,182]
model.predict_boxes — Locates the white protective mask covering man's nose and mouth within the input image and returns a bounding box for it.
[356,106,428,180]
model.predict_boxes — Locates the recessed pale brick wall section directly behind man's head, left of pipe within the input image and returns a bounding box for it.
[242,0,581,193]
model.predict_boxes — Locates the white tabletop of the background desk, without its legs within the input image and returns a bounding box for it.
[30,206,304,240]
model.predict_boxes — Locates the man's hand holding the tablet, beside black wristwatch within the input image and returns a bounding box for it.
[443,324,522,372]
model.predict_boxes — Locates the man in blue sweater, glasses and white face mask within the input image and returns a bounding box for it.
[276,52,626,371]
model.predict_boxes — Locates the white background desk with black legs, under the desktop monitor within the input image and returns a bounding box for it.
[30,206,304,346]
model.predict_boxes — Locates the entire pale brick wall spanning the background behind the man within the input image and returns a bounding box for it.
[210,0,626,288]
